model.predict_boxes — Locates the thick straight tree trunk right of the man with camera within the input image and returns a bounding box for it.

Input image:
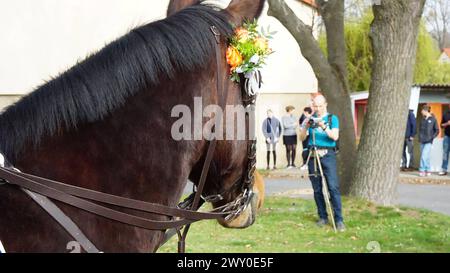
[351,0,425,205]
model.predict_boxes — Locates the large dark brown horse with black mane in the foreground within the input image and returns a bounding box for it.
[0,0,264,252]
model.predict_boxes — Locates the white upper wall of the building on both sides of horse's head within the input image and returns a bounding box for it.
[0,0,317,94]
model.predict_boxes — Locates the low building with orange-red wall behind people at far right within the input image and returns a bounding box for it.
[350,84,450,172]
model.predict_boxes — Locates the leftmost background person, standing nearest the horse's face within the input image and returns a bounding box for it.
[262,109,281,170]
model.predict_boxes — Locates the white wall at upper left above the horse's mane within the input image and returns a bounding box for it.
[0,0,168,94]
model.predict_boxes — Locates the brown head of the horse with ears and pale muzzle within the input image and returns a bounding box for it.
[167,0,265,228]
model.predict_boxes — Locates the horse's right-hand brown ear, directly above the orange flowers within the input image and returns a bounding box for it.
[226,0,266,26]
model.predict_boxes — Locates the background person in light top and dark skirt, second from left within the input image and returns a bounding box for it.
[281,105,298,169]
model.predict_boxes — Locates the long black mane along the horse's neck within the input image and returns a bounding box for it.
[0,5,232,160]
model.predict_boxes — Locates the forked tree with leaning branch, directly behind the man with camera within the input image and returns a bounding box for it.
[268,0,356,194]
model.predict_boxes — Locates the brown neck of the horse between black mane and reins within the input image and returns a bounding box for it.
[16,70,214,205]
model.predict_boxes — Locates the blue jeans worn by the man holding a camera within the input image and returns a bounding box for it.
[308,151,344,223]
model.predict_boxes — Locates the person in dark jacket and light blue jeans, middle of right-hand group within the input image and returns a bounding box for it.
[419,105,439,177]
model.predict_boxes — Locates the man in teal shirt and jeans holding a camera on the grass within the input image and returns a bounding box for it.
[300,95,345,231]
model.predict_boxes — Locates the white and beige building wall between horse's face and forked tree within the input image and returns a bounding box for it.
[256,0,317,168]
